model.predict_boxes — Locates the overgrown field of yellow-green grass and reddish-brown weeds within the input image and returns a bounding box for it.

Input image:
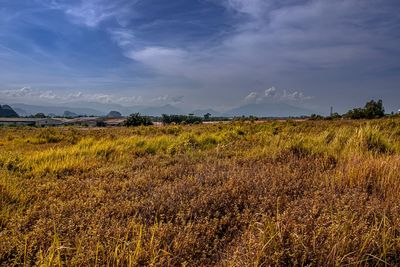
[0,118,400,266]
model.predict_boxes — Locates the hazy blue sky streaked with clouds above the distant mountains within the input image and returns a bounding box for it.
[0,0,400,113]
